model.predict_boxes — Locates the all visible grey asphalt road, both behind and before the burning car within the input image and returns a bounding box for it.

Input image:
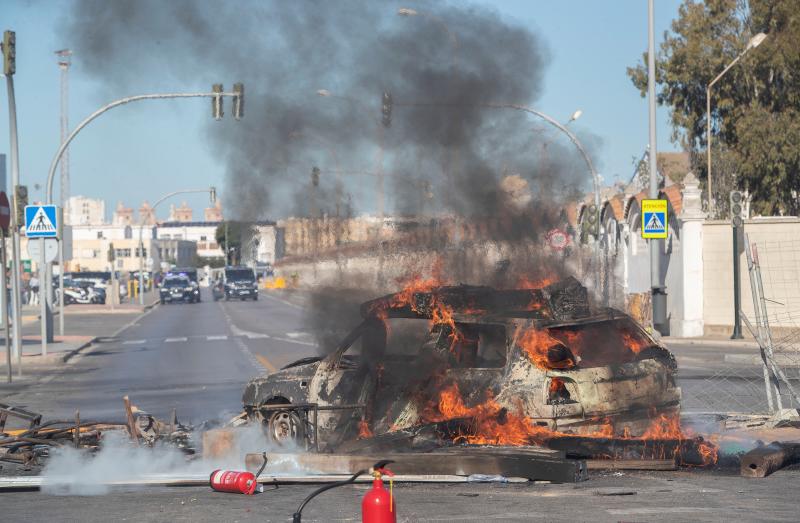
[0,291,800,522]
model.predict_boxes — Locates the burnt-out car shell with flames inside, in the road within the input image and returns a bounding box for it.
[243,278,680,449]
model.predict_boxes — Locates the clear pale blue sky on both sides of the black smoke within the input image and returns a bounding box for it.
[0,0,681,219]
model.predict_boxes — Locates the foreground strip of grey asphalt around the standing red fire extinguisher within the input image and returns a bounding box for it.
[0,470,800,523]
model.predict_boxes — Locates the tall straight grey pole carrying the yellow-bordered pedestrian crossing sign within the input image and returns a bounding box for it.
[647,0,668,334]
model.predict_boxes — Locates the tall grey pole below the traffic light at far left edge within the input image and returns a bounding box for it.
[6,75,22,376]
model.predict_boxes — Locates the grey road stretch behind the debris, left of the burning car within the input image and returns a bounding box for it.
[5,289,316,423]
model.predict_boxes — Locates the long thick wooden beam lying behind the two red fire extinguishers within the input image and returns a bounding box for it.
[245,449,587,483]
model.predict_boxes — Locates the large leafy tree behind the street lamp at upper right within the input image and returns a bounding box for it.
[628,0,800,214]
